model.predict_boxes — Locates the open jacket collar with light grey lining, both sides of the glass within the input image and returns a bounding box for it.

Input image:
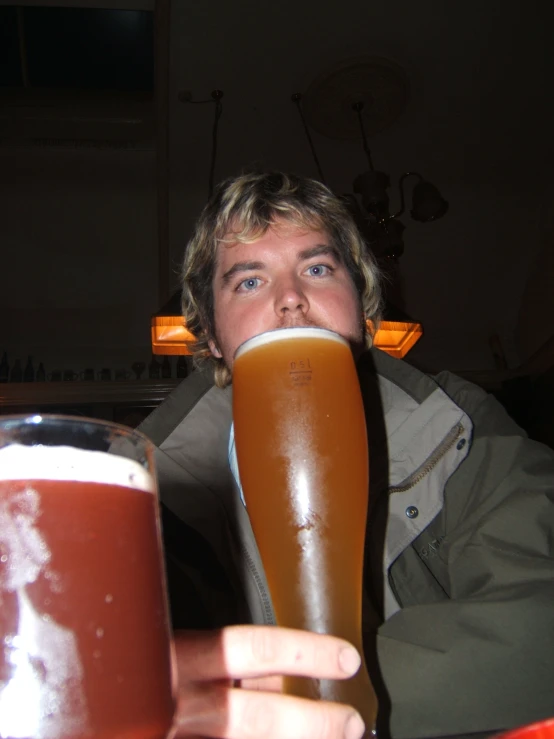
[141,349,471,512]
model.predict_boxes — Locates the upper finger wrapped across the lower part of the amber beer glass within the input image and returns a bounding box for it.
[175,626,360,680]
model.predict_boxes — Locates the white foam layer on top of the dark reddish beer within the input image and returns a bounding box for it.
[0,444,155,493]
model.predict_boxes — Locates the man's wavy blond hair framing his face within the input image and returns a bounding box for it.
[182,172,381,387]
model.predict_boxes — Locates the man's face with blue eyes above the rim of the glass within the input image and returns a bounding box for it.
[210,223,364,369]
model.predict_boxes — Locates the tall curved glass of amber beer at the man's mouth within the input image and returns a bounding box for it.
[233,328,377,730]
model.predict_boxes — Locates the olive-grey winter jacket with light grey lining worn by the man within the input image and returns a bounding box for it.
[141,350,554,739]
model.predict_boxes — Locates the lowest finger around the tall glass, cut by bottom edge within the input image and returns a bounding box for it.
[175,683,364,739]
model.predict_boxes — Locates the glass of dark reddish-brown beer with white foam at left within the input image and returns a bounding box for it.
[0,415,174,739]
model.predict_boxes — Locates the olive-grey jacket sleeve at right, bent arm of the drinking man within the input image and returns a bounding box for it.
[377,385,554,739]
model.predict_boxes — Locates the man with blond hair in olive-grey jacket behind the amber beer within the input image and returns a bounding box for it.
[143,173,554,739]
